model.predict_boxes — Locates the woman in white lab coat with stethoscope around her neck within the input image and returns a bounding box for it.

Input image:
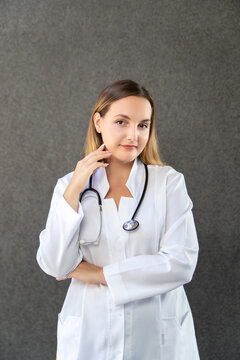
[37,80,199,360]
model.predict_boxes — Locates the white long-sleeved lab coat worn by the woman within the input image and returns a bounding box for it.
[37,158,199,360]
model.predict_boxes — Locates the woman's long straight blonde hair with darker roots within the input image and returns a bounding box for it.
[84,80,167,166]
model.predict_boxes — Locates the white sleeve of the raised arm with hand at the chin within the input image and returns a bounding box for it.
[36,178,84,278]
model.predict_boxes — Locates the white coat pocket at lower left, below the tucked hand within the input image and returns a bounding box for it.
[57,313,82,360]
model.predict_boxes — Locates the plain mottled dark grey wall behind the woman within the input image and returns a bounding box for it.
[0,0,240,360]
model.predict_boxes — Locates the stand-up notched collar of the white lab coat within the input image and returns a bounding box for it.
[92,157,145,200]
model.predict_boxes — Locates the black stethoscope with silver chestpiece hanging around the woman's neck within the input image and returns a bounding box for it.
[79,164,148,245]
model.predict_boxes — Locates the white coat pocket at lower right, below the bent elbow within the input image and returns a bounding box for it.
[160,310,190,360]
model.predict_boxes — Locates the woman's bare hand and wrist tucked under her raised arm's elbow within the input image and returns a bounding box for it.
[56,260,107,285]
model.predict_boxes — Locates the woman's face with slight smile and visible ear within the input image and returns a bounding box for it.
[94,96,152,163]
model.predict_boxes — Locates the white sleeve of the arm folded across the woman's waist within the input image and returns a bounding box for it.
[103,170,199,305]
